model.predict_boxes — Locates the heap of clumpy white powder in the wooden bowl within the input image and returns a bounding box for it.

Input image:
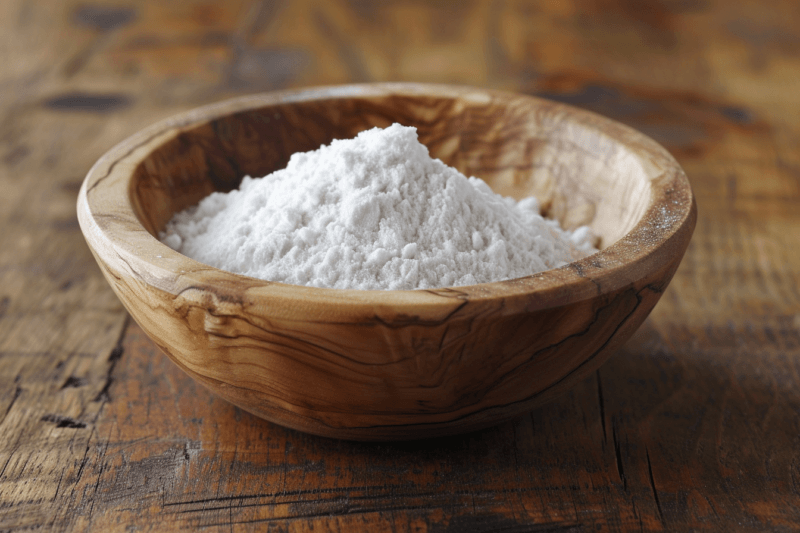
[160,124,596,289]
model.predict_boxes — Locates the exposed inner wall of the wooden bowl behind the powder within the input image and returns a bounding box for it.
[129,94,653,248]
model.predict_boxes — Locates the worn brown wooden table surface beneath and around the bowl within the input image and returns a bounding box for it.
[0,0,800,533]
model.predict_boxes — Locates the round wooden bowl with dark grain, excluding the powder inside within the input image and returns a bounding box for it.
[78,84,696,440]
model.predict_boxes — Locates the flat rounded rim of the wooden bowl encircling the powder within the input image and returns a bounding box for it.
[77,83,697,319]
